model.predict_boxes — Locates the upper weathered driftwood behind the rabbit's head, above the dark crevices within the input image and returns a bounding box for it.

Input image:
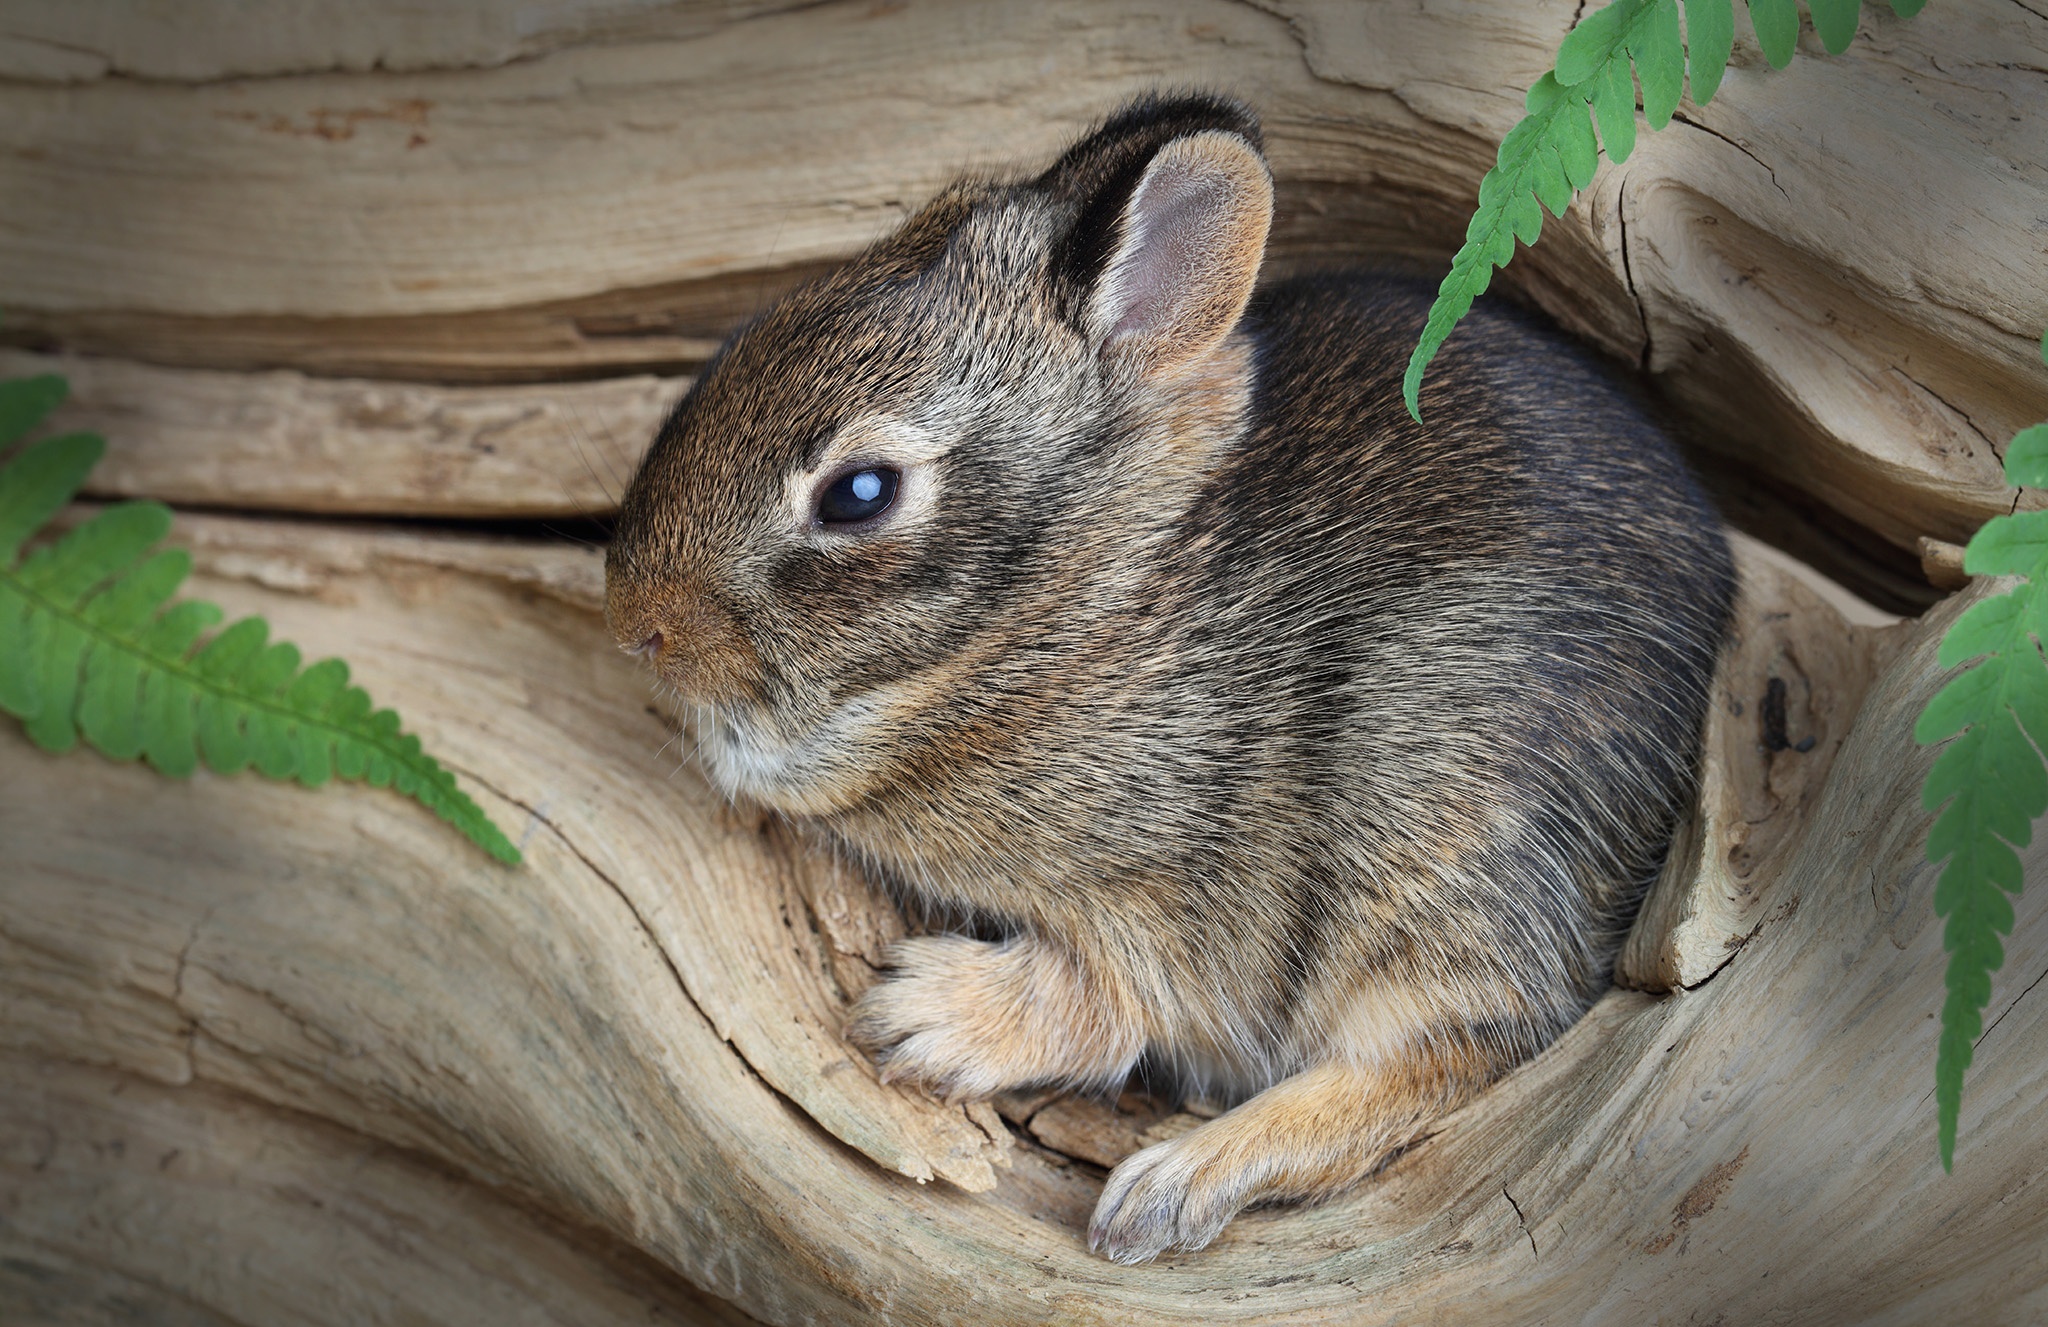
[0,0,2048,551]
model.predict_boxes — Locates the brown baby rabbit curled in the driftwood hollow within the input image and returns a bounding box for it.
[606,96,1733,1261]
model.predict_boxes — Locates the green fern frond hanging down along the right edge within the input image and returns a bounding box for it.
[1913,325,2048,1169]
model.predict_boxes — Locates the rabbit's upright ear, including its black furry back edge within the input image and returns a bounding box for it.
[1038,96,1272,377]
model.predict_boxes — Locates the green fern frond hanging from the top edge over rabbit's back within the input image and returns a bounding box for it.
[1401,0,1925,424]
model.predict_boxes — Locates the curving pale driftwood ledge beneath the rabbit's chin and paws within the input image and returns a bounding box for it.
[0,518,2048,1323]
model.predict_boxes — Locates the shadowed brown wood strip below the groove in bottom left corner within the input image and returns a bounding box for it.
[0,1055,754,1327]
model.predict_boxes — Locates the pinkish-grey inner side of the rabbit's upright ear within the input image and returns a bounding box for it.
[1092,133,1272,373]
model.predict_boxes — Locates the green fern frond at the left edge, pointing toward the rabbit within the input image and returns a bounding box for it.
[0,377,520,862]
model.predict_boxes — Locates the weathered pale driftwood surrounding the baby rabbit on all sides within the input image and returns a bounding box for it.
[0,0,2048,1325]
